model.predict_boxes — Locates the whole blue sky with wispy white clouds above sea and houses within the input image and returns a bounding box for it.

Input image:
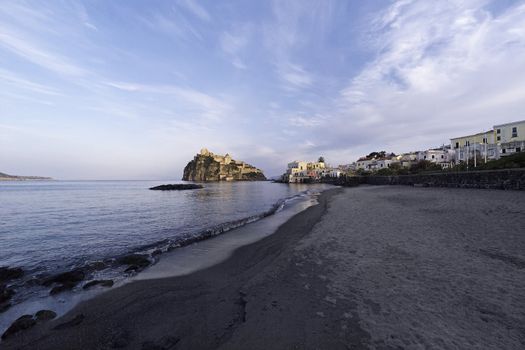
[0,0,525,179]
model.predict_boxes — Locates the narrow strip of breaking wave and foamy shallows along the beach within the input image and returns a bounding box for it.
[0,185,329,334]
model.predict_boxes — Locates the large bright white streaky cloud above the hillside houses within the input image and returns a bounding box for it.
[331,0,525,156]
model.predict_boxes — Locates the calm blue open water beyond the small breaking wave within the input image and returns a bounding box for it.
[0,181,328,272]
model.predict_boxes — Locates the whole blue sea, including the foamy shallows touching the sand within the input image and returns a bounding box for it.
[0,181,331,333]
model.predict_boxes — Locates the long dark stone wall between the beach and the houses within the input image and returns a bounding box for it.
[325,169,525,190]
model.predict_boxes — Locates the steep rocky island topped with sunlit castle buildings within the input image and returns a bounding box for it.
[182,148,266,181]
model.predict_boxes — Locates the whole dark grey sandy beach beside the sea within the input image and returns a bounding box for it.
[4,186,525,349]
